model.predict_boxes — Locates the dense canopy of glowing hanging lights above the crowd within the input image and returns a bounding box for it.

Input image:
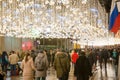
[0,0,114,42]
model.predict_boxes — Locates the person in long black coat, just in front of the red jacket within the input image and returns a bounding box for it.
[74,52,92,80]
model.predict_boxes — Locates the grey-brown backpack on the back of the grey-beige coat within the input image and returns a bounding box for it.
[36,57,45,71]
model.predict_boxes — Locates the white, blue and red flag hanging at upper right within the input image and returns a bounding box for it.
[109,1,120,34]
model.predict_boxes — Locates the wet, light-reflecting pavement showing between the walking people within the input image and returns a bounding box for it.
[6,64,116,80]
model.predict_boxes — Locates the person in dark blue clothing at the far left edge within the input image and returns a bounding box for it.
[2,51,9,73]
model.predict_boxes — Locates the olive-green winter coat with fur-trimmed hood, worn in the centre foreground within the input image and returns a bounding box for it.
[54,52,70,78]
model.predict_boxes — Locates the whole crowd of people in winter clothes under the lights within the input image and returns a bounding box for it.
[0,48,120,80]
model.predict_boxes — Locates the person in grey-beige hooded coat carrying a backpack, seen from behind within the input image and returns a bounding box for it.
[35,51,49,80]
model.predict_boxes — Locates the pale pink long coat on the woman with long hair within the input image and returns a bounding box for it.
[21,57,35,80]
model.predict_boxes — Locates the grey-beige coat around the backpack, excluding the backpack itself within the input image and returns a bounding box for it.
[35,53,48,77]
